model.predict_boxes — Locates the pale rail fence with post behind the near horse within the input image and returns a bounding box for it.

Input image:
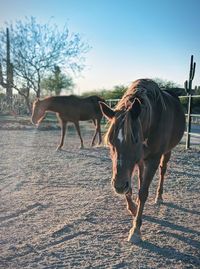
[106,95,200,149]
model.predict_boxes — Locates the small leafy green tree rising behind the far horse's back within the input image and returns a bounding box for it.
[41,66,75,95]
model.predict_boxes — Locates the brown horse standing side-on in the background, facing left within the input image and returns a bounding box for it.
[31,95,104,149]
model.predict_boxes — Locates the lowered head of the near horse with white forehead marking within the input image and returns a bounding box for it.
[100,99,143,194]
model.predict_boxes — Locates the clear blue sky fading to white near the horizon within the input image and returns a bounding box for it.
[0,0,200,93]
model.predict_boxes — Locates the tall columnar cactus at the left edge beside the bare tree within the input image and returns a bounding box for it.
[0,28,13,108]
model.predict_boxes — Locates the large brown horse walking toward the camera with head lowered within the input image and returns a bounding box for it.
[100,79,185,243]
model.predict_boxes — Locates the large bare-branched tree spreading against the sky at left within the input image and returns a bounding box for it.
[0,17,89,113]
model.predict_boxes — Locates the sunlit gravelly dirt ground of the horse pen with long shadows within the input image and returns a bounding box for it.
[0,130,200,269]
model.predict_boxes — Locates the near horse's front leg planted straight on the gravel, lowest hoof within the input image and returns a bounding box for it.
[128,157,160,243]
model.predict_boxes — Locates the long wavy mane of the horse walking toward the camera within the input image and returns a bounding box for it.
[105,79,165,144]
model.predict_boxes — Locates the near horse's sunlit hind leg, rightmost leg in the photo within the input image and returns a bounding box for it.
[155,151,171,203]
